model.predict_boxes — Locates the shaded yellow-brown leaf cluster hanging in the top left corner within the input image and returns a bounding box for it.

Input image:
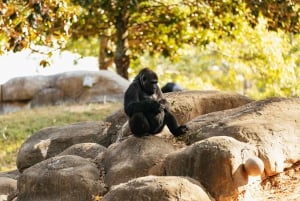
[0,0,78,54]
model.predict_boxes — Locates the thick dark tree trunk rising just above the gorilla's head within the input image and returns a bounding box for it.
[115,11,130,79]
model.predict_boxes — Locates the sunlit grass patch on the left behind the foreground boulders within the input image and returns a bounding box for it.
[0,103,122,172]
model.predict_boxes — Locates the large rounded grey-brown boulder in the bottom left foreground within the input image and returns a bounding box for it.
[17,155,106,201]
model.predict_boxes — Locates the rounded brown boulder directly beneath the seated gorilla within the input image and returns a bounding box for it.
[97,136,176,186]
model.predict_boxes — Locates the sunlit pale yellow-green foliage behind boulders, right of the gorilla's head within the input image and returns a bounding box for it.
[131,18,300,99]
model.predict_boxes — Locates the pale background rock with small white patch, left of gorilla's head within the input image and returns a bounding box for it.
[55,70,129,103]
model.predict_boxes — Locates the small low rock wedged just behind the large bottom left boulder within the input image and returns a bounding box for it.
[59,143,106,159]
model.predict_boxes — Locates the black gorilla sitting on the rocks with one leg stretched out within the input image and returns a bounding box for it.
[124,68,188,137]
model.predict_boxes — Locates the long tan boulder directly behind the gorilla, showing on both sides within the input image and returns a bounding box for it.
[105,91,253,141]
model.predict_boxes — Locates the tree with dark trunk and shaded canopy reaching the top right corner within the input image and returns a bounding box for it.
[65,0,299,78]
